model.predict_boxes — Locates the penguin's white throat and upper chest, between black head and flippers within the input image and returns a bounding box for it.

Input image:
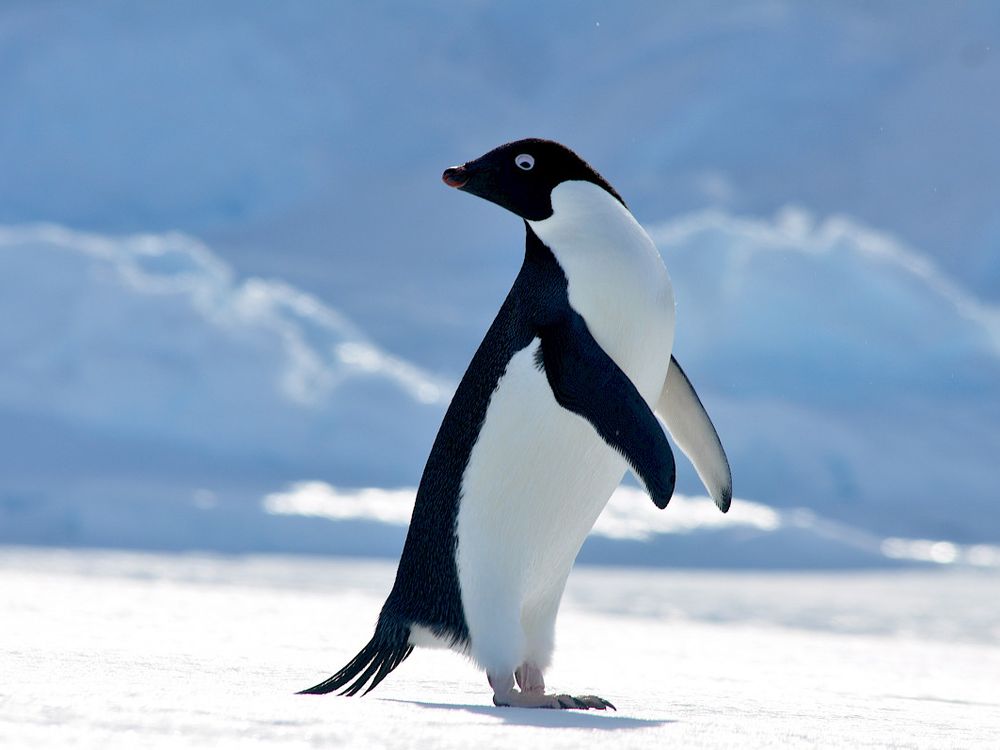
[528,181,674,388]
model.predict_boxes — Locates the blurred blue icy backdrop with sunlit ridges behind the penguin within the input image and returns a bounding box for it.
[0,1,1000,568]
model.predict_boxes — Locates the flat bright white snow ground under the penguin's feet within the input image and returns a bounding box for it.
[0,547,1000,748]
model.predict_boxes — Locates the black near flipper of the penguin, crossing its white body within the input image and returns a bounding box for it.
[535,313,675,508]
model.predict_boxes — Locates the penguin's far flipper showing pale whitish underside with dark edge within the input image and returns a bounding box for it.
[656,357,733,513]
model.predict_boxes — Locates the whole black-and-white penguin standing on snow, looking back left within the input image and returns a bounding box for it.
[301,138,732,709]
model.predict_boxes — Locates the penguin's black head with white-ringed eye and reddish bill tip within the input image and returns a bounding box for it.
[441,138,625,221]
